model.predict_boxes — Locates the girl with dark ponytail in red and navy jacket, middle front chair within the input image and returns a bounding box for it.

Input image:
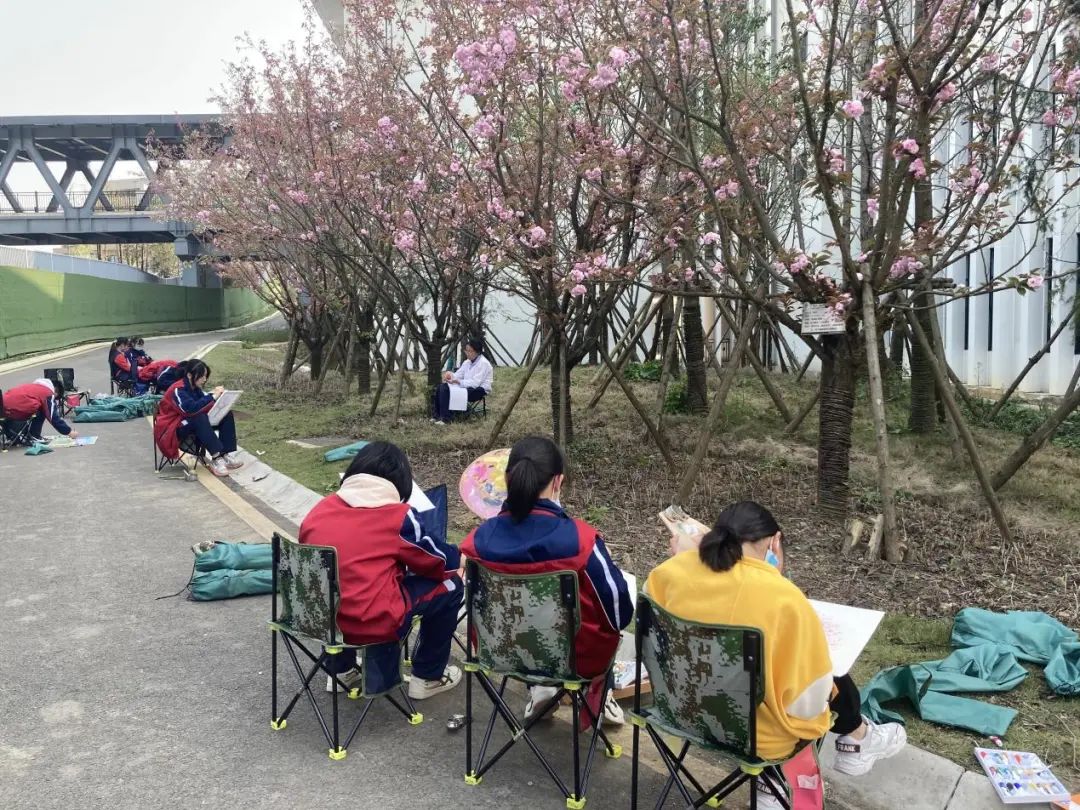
[461,436,634,724]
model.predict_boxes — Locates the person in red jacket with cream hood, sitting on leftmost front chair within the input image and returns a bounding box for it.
[300,442,462,700]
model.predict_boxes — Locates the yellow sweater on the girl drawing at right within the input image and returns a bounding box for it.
[645,550,833,759]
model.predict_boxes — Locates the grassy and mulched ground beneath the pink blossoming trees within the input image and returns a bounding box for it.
[207,336,1080,789]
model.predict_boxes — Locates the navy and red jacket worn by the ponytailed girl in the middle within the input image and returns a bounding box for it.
[461,500,634,678]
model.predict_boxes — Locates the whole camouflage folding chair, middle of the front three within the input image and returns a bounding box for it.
[464,559,622,810]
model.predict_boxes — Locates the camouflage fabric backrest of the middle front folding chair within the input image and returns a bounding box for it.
[472,566,582,683]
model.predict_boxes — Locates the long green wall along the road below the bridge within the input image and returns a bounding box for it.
[0,267,270,359]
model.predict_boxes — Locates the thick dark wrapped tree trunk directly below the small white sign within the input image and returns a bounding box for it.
[818,334,858,517]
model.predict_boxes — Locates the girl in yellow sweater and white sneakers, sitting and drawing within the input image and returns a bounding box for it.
[645,501,907,810]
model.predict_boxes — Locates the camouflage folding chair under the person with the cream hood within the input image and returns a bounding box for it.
[270,532,423,759]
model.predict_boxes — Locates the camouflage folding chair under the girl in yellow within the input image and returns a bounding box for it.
[630,594,812,810]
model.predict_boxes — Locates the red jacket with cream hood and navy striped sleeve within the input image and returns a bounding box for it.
[300,475,461,644]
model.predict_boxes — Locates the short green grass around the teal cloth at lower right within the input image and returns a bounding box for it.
[852,615,1080,786]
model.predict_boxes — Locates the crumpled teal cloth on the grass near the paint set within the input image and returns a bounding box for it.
[862,608,1080,737]
